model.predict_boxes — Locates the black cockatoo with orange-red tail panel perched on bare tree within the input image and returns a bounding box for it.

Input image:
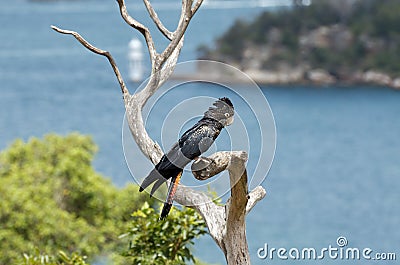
[139,97,234,219]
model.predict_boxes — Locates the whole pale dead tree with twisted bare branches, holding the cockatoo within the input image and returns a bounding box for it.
[52,0,266,265]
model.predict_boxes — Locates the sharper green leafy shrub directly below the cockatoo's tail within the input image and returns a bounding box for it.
[119,203,206,265]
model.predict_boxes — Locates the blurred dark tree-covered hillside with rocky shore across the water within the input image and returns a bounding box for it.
[200,0,400,85]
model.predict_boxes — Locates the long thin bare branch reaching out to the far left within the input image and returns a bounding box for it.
[51,25,130,101]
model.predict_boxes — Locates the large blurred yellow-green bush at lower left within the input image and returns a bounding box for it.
[0,133,147,264]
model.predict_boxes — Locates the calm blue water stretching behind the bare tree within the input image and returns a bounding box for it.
[0,0,400,264]
